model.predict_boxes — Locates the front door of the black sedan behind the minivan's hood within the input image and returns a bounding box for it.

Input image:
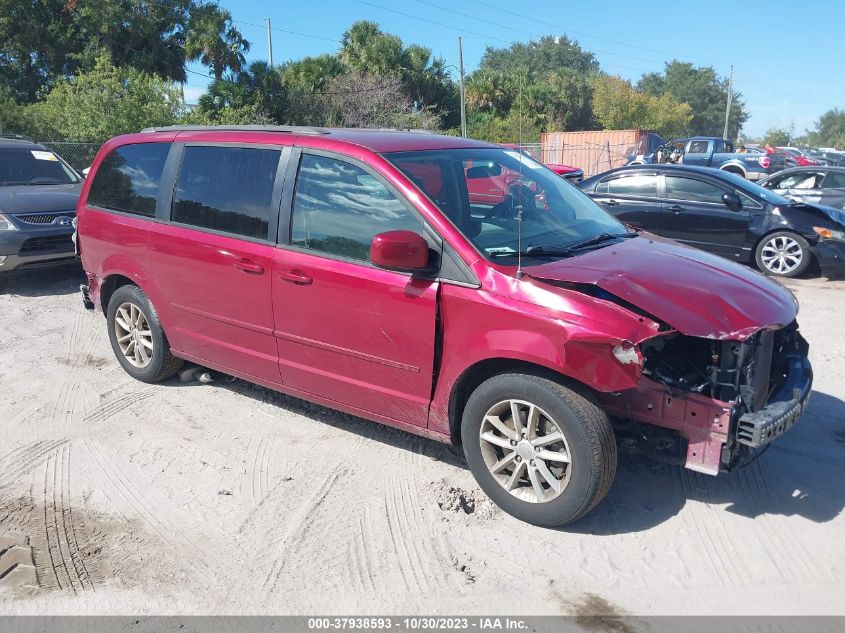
[655,175,752,259]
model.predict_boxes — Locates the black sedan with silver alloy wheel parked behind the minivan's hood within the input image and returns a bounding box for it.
[578,165,845,277]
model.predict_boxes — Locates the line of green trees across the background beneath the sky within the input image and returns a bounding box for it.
[0,0,836,143]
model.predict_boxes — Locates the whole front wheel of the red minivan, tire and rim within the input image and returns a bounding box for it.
[461,374,617,527]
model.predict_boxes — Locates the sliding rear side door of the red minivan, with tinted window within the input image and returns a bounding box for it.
[150,145,282,383]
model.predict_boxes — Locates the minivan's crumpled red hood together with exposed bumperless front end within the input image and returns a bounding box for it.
[531,236,813,475]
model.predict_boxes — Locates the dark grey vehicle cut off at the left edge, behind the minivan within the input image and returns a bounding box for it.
[0,138,82,274]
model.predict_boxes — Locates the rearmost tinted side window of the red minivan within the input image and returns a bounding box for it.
[88,143,170,218]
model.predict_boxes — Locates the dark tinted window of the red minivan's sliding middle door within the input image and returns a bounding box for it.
[173,146,282,240]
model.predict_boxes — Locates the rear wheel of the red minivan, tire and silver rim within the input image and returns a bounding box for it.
[106,285,183,383]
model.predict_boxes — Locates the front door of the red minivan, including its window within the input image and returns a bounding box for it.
[272,153,438,426]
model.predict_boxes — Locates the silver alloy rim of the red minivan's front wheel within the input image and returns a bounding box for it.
[479,400,572,503]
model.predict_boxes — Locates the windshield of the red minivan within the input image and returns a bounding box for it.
[385,148,627,265]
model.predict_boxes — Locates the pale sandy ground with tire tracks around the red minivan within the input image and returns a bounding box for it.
[0,268,845,615]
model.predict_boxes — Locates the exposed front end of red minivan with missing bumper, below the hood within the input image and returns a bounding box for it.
[602,322,812,475]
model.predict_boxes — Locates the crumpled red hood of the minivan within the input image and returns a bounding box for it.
[526,234,798,340]
